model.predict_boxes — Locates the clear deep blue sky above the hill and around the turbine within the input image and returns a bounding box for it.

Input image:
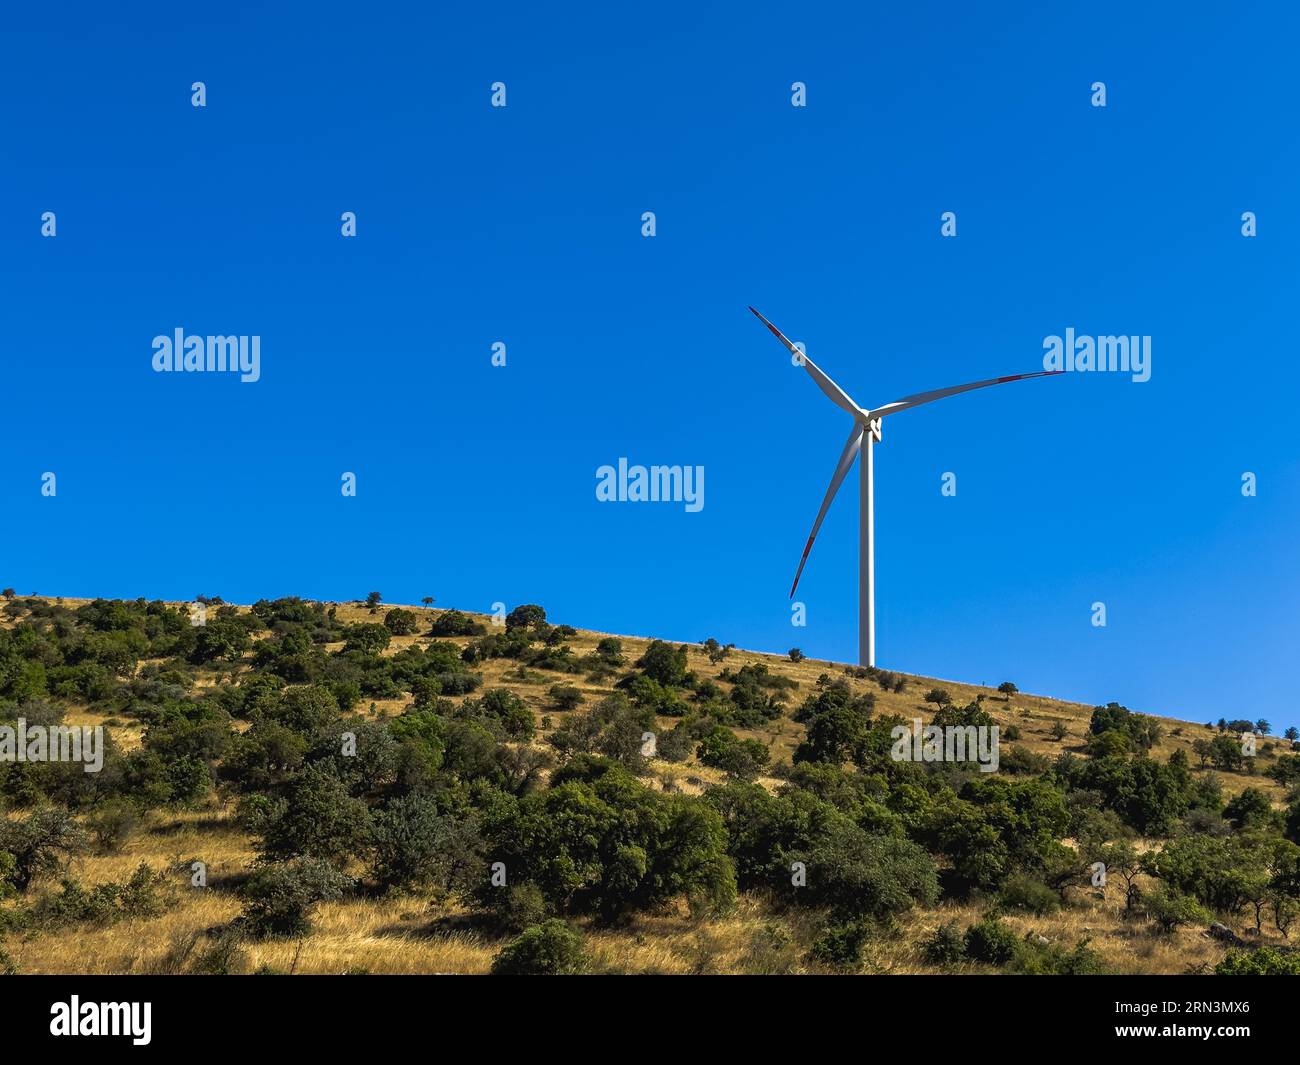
[0,3,1300,730]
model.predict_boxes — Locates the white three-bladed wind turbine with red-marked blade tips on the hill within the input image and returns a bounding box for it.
[749,307,1065,666]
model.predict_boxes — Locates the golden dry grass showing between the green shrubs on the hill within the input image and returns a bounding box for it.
[0,598,1291,974]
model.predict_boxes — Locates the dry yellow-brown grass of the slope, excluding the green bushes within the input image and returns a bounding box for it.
[7,598,1283,974]
